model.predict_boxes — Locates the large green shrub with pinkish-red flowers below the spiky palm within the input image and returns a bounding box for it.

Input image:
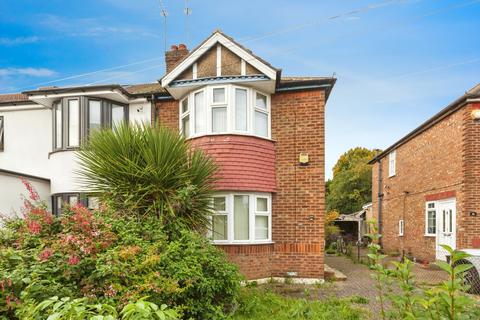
[0,181,241,319]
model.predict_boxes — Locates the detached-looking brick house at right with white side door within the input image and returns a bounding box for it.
[370,85,480,262]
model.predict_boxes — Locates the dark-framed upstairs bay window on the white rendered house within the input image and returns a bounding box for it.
[53,97,128,150]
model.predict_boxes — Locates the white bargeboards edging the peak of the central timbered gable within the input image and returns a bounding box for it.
[159,30,280,88]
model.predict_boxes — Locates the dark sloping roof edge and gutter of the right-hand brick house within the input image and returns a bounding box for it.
[369,84,480,164]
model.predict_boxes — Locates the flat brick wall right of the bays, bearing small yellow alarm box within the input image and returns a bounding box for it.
[272,90,325,278]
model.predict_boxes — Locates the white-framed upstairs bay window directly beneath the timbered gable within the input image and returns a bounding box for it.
[179,85,270,138]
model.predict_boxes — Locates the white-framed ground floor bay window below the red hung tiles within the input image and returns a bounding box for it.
[210,193,272,244]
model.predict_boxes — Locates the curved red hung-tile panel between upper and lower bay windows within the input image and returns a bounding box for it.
[190,135,275,192]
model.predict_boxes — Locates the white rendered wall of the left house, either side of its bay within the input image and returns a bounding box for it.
[0,99,152,202]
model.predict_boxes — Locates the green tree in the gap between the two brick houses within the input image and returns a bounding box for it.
[326,147,379,213]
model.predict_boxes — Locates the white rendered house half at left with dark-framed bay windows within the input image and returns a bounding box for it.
[0,84,160,216]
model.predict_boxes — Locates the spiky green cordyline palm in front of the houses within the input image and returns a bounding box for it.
[78,124,217,231]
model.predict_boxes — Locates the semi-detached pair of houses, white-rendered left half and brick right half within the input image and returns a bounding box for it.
[0,31,335,281]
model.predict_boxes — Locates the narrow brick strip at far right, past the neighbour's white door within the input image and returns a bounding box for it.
[457,103,480,249]
